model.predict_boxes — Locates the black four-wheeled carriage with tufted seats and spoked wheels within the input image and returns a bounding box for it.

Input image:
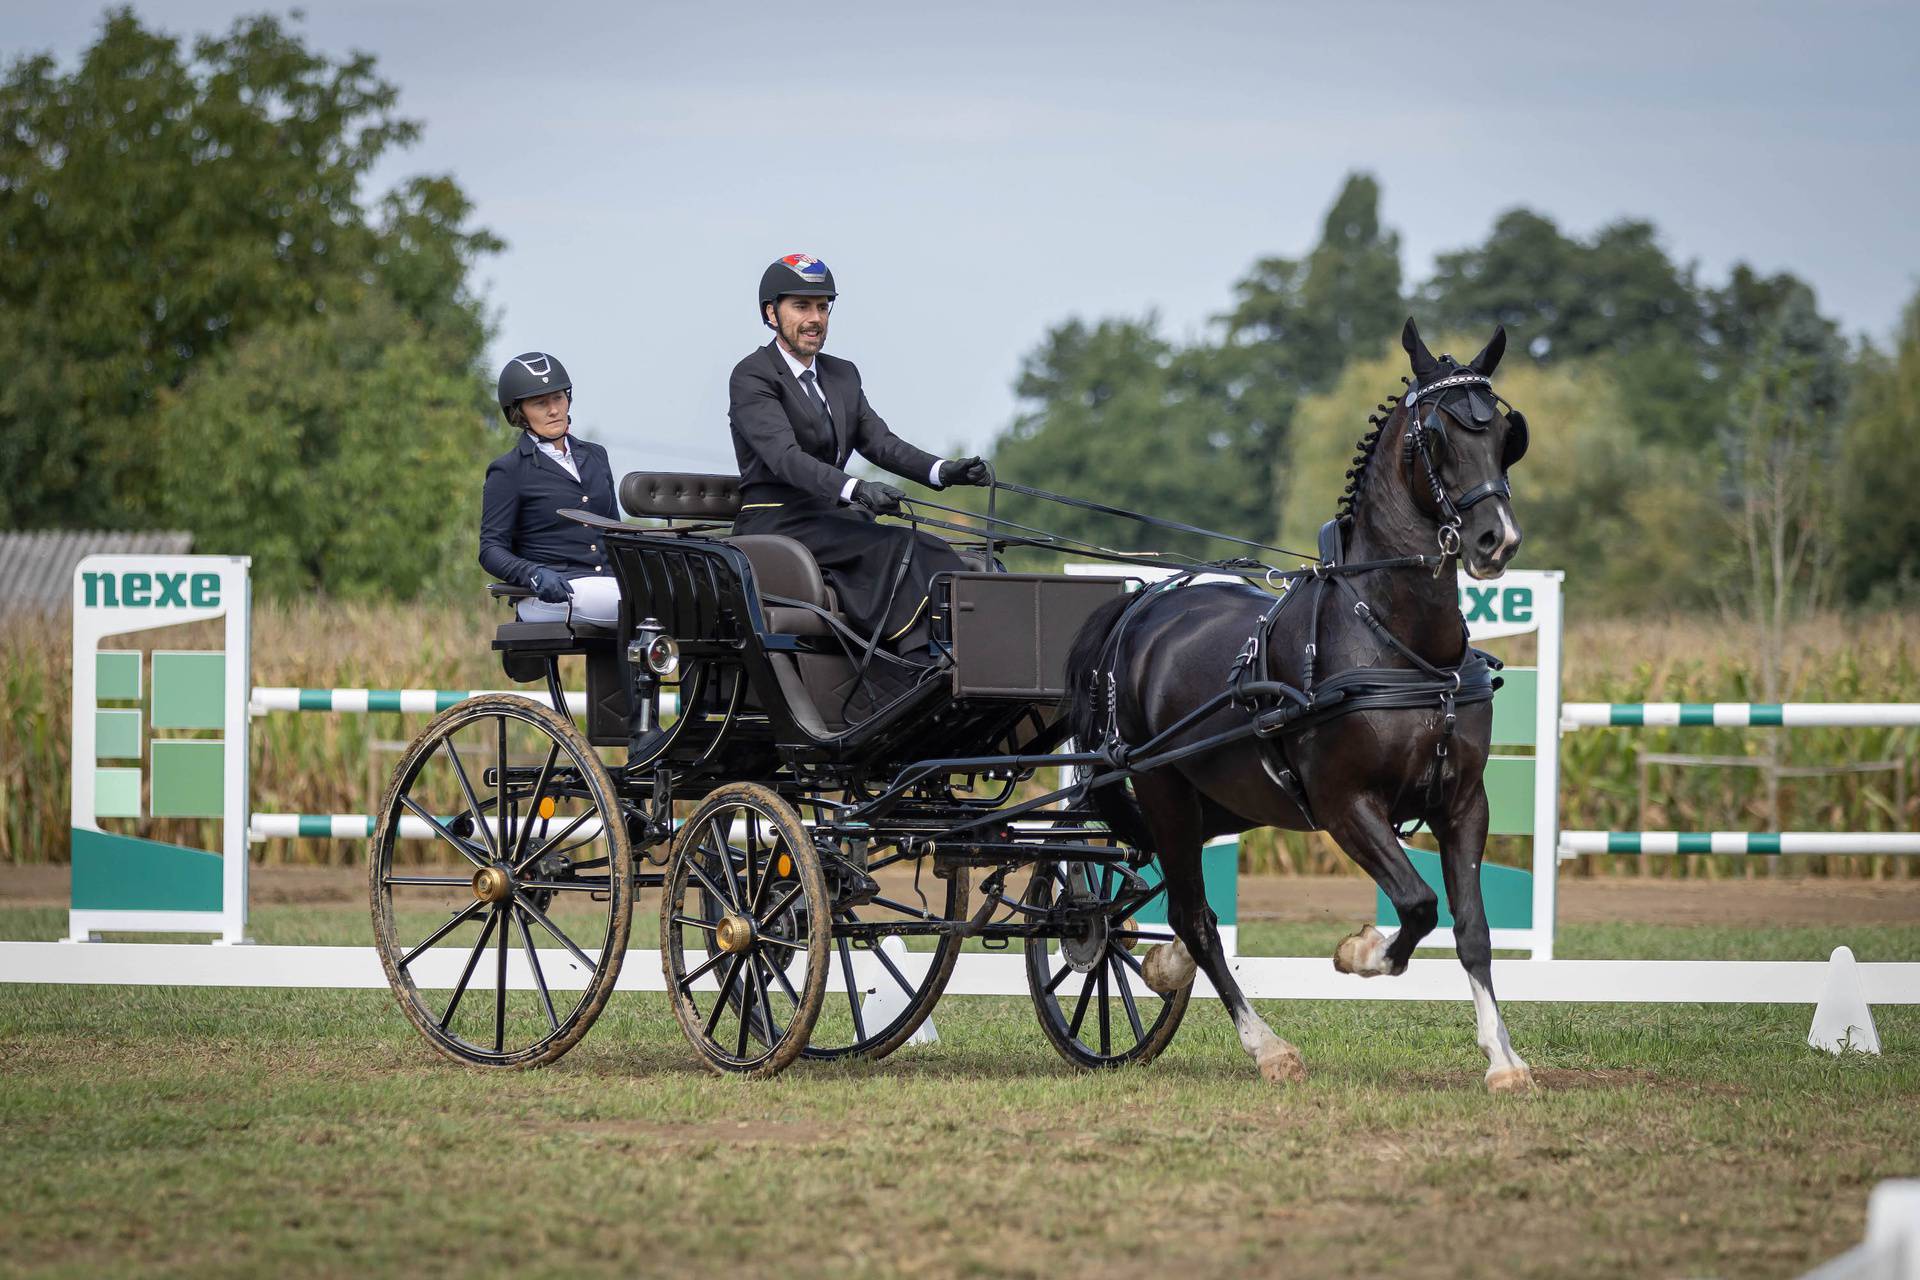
[371,474,1190,1075]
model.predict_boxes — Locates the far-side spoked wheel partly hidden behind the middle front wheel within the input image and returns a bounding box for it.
[806,856,968,1059]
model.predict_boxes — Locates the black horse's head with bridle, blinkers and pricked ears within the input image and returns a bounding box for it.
[1400,319,1526,578]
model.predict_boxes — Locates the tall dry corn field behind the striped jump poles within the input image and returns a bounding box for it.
[0,603,1920,877]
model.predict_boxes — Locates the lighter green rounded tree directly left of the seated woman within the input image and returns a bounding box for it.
[146,294,501,597]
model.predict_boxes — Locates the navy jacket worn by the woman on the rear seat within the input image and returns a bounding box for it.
[480,432,620,587]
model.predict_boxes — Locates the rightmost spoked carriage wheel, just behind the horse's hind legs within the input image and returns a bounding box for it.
[1027,862,1192,1069]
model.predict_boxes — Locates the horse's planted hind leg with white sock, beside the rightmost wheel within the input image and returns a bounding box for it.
[1133,771,1308,1084]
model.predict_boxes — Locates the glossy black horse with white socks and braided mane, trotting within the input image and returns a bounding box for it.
[1068,319,1532,1090]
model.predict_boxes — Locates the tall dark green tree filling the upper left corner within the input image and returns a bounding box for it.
[0,10,499,552]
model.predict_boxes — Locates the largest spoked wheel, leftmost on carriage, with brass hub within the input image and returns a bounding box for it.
[369,695,634,1067]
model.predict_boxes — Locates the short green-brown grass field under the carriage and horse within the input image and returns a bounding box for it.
[0,882,1920,1276]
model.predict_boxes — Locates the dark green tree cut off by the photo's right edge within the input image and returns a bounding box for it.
[1839,292,1920,601]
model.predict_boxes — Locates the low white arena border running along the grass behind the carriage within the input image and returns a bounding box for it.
[0,942,1920,1006]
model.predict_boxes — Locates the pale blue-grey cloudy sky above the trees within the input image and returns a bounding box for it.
[15,0,1920,483]
